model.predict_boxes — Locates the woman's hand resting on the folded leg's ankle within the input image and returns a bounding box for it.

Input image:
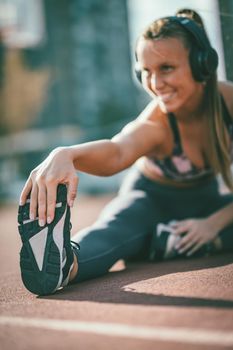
[172,218,218,256]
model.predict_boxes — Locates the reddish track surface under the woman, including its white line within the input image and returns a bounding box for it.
[0,196,233,350]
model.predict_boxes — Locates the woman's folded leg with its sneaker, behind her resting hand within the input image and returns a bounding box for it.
[144,181,233,260]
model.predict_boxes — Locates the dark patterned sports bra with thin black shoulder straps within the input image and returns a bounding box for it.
[147,96,233,182]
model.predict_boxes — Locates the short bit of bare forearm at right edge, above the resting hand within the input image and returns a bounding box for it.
[208,203,233,232]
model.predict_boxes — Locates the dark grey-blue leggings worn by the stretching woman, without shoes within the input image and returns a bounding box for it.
[72,169,233,283]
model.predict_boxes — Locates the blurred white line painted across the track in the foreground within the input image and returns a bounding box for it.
[0,316,233,347]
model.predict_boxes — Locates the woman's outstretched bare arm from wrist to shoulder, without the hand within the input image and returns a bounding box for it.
[69,116,165,176]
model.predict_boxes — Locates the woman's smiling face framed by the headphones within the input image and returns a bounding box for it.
[137,38,204,116]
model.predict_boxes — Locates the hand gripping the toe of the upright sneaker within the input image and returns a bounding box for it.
[20,147,78,226]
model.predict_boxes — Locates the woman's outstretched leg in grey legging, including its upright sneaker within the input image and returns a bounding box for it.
[18,170,159,295]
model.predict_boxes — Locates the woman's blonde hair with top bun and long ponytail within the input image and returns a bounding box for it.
[138,9,233,191]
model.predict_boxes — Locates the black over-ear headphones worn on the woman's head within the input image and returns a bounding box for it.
[135,16,218,83]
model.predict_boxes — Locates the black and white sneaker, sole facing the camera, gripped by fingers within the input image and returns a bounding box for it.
[18,184,79,295]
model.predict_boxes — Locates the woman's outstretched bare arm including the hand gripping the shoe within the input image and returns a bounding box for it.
[20,100,166,223]
